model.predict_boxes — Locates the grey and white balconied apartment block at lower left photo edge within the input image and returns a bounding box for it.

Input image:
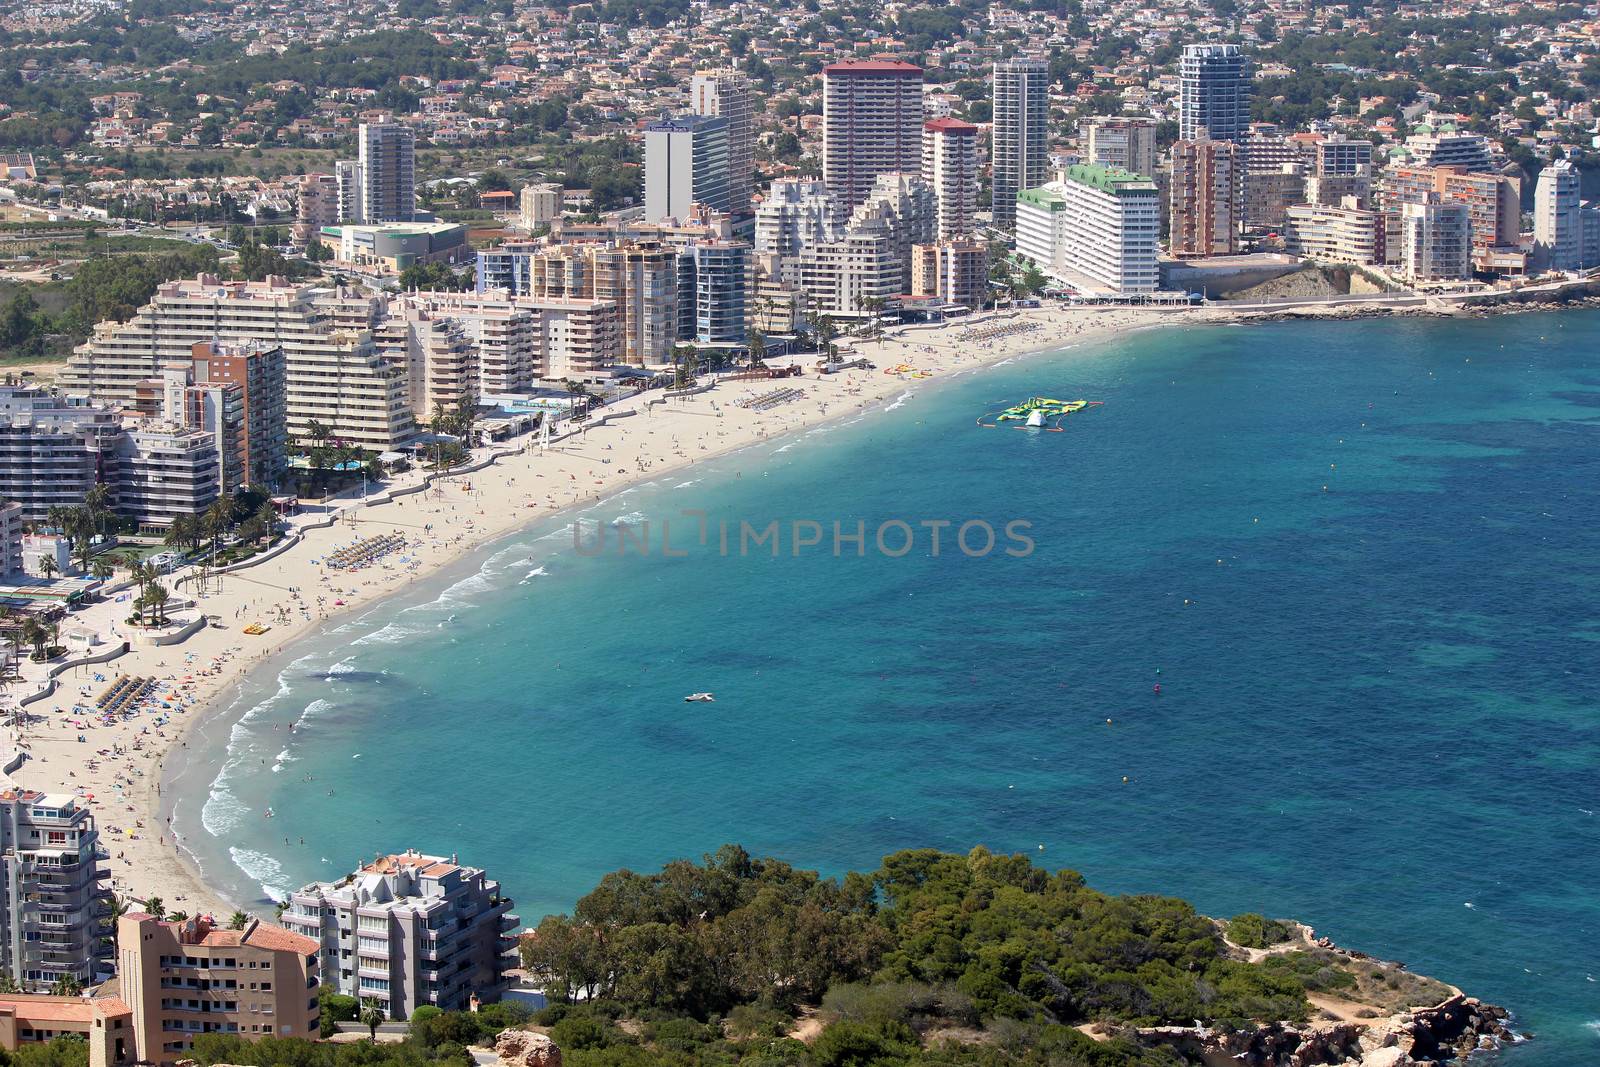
[0,793,112,992]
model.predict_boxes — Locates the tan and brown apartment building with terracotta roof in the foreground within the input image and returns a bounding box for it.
[117,912,322,1067]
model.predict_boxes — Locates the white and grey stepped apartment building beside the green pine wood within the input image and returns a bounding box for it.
[283,851,518,1019]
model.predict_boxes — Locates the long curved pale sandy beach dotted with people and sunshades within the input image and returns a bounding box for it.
[10,307,1190,913]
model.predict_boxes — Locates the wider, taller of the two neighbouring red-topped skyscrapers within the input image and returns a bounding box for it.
[822,59,922,213]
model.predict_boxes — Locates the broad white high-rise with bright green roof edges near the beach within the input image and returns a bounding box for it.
[1016,165,1162,294]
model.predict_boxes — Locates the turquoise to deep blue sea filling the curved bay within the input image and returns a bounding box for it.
[168,312,1600,1067]
